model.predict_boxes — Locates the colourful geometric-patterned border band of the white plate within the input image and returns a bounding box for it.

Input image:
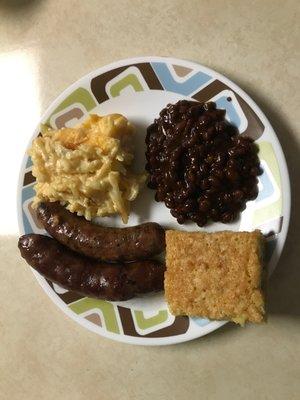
[18,57,290,345]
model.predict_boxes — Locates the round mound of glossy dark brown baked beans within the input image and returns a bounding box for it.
[146,100,261,226]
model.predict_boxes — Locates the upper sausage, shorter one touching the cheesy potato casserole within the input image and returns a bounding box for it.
[37,202,165,261]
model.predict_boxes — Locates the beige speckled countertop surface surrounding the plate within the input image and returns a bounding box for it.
[0,0,300,400]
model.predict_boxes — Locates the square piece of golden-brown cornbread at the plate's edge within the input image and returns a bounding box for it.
[165,230,265,324]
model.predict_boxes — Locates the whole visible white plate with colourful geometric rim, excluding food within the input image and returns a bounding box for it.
[18,57,290,345]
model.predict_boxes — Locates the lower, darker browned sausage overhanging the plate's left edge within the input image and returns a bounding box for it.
[18,234,165,301]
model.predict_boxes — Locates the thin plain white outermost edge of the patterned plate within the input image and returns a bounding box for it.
[17,56,291,346]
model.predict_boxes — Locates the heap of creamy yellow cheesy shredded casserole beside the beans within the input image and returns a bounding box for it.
[29,114,146,223]
